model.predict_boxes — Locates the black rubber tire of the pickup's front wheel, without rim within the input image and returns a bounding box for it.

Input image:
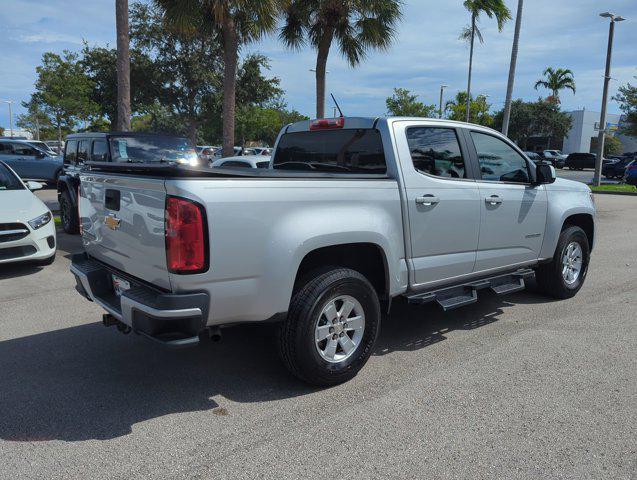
[536,225,590,300]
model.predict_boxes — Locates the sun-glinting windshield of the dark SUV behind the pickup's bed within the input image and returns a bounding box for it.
[110,136,199,166]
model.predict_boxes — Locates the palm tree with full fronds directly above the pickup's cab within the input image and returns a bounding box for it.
[280,0,402,118]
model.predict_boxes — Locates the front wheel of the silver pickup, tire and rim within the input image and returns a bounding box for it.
[536,226,590,299]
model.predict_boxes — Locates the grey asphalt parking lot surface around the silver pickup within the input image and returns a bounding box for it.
[0,195,637,480]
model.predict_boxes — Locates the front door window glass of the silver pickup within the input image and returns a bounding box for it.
[471,132,530,183]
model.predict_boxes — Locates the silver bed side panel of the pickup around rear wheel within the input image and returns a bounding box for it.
[166,179,407,325]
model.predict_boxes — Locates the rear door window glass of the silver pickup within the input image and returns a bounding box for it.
[407,127,467,178]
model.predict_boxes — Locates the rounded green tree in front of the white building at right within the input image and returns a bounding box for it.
[493,99,573,149]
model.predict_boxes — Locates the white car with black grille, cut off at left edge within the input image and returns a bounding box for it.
[0,162,56,265]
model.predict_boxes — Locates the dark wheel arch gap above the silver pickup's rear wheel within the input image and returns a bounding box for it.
[293,243,389,301]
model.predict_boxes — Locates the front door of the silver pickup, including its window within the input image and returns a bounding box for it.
[469,131,548,272]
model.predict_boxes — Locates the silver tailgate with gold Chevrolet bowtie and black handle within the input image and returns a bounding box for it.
[79,173,170,289]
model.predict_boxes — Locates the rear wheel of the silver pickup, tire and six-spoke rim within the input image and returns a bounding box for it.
[278,268,380,386]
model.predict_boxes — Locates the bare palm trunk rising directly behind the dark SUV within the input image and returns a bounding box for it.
[115,0,131,132]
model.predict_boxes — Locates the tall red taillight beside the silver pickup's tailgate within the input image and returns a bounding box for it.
[166,197,208,273]
